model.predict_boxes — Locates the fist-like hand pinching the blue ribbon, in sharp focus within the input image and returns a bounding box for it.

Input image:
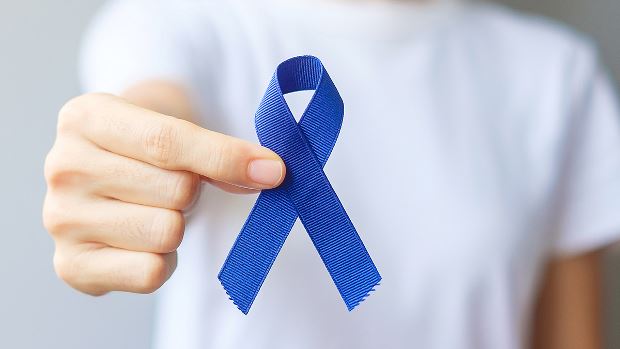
[43,94,285,295]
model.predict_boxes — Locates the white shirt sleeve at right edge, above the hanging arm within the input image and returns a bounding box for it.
[553,42,620,255]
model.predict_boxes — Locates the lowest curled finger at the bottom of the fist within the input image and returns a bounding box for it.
[54,244,177,295]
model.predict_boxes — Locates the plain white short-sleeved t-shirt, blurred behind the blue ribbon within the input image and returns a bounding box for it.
[81,0,620,349]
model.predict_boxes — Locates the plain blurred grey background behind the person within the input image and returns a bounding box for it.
[0,0,620,349]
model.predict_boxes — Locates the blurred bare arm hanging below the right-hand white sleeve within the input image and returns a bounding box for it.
[532,251,603,349]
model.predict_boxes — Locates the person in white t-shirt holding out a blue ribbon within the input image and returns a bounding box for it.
[43,0,620,349]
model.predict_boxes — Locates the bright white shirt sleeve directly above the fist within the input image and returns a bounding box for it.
[79,0,193,94]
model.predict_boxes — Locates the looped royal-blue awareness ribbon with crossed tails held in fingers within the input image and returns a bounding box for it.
[218,56,381,314]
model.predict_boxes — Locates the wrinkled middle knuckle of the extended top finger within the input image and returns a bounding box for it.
[144,122,180,166]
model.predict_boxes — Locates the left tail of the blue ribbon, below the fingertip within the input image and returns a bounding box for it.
[218,189,297,315]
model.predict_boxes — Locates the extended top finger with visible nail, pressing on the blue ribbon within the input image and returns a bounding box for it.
[59,95,285,189]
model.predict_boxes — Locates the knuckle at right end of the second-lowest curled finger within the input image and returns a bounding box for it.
[151,211,185,253]
